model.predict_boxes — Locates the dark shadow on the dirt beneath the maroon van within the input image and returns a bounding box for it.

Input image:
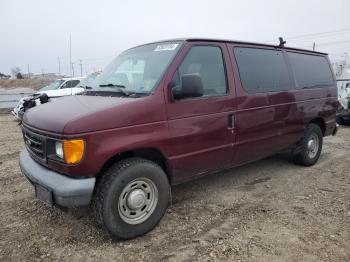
[65,150,294,243]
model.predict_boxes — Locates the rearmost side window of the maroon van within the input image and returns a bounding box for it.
[288,52,333,89]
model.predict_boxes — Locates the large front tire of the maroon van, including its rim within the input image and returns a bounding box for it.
[94,158,170,239]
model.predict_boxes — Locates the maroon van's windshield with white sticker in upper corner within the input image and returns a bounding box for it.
[91,42,180,95]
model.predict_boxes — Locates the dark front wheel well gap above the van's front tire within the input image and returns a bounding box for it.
[99,148,171,184]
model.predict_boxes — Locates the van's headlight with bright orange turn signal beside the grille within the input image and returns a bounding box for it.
[55,139,85,164]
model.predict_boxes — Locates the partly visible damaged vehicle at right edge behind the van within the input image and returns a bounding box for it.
[337,79,350,125]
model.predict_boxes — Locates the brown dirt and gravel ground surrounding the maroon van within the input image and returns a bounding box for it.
[0,114,350,261]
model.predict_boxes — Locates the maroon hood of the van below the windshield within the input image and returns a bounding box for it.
[23,95,165,134]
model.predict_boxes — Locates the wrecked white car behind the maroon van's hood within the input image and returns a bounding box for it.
[12,74,92,119]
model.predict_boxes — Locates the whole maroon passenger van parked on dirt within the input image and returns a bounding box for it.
[20,39,337,239]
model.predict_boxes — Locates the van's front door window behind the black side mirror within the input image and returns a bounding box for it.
[172,46,227,96]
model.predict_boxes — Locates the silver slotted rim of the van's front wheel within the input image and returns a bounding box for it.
[118,178,158,225]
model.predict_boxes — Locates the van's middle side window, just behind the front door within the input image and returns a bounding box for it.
[233,47,289,93]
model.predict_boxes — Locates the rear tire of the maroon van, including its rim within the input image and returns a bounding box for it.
[293,124,323,166]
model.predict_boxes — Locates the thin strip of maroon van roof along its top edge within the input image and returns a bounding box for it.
[145,38,328,55]
